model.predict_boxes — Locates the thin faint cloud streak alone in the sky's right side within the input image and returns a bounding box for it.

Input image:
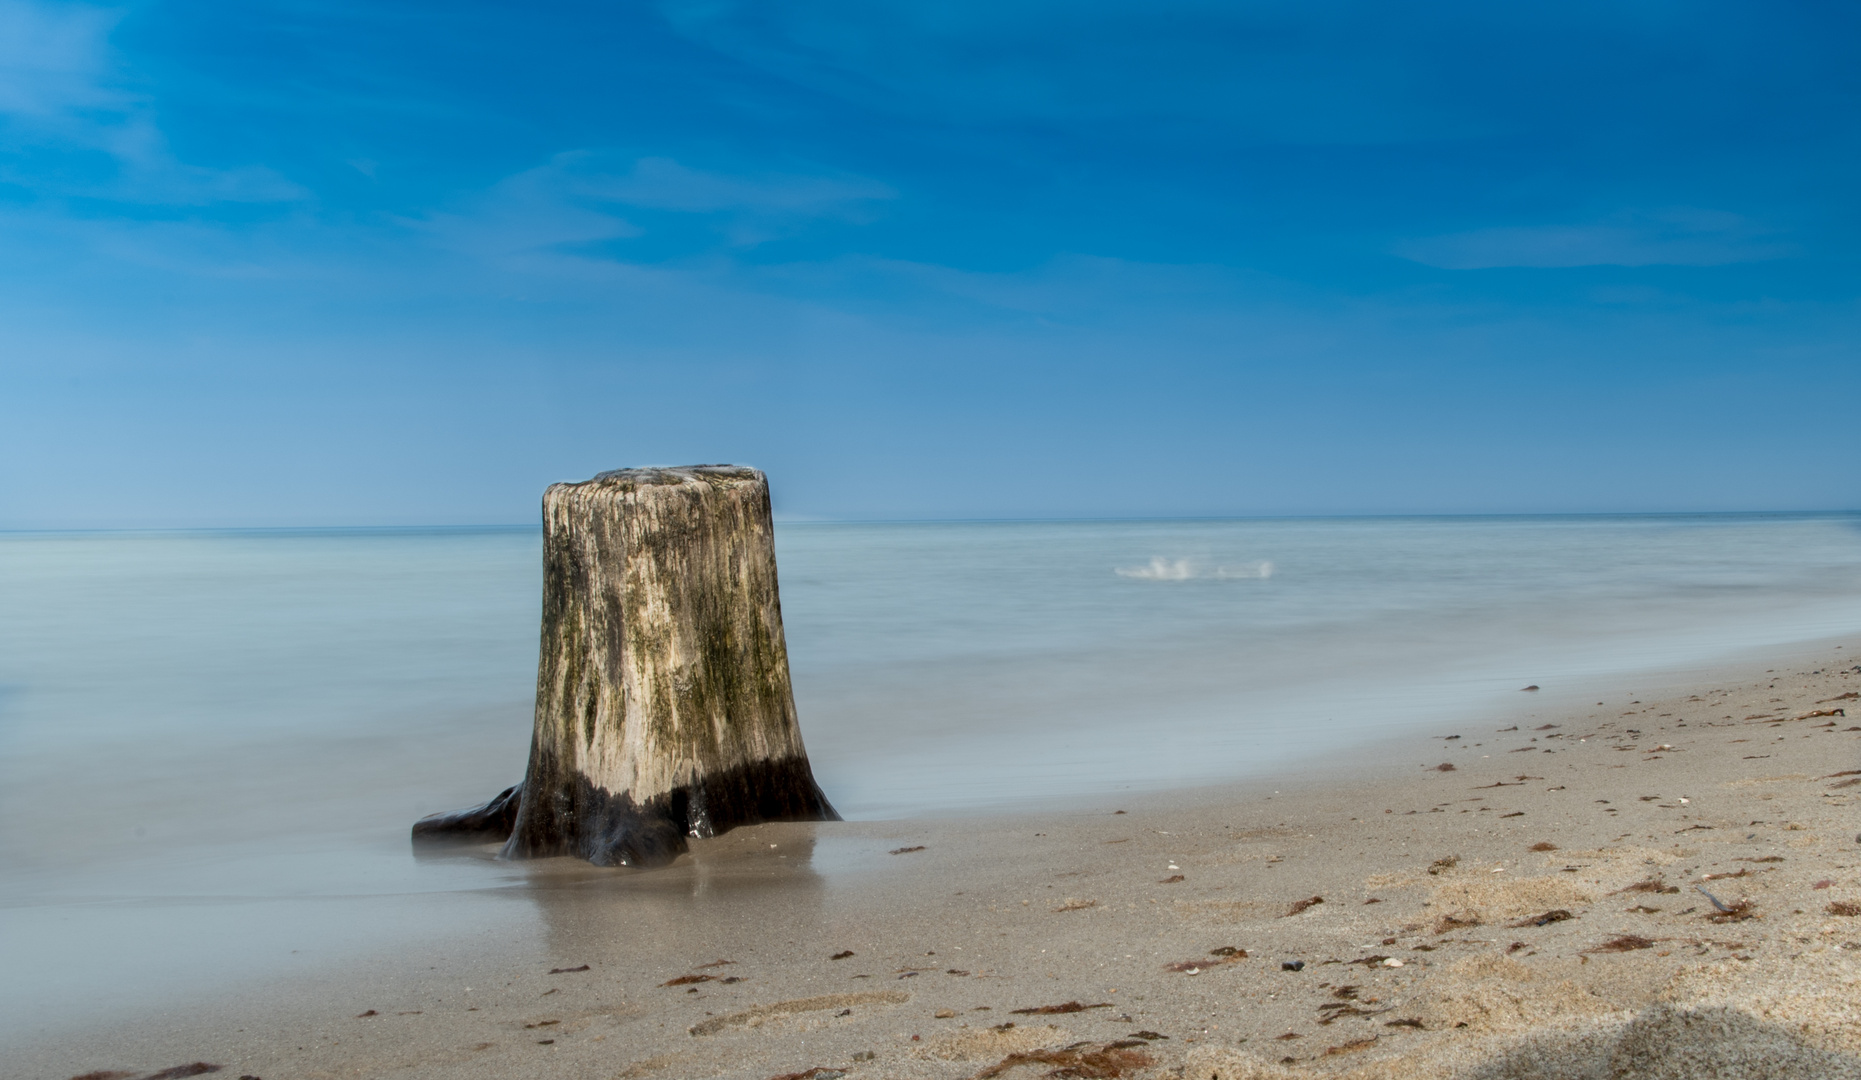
[1394,209,1794,270]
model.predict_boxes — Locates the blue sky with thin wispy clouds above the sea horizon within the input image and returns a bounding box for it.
[0,0,1861,527]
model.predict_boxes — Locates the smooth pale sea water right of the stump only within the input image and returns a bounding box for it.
[782,516,1861,814]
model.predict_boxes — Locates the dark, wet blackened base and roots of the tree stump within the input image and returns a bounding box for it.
[413,758,839,868]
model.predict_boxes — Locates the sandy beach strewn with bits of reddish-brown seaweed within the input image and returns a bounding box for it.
[21,641,1861,1080]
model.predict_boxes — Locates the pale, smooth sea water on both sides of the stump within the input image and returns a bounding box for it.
[0,514,1861,1037]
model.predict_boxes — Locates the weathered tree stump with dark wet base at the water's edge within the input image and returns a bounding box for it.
[413,466,839,866]
